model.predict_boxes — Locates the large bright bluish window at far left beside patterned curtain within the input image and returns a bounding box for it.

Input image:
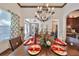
[0,10,11,41]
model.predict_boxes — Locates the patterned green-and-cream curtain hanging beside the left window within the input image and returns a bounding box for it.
[10,12,21,38]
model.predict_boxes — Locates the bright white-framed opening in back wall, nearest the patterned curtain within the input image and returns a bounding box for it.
[24,18,39,39]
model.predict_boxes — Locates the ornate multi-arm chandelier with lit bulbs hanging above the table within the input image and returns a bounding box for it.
[35,4,55,22]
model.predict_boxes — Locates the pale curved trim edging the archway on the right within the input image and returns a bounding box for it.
[62,7,79,41]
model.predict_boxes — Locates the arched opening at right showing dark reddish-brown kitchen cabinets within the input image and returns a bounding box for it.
[66,9,79,38]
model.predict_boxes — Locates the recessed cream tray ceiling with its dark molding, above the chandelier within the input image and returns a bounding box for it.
[17,3,66,8]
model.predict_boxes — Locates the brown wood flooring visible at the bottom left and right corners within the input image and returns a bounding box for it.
[0,45,79,56]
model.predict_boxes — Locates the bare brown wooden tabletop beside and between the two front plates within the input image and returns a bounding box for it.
[9,44,67,56]
